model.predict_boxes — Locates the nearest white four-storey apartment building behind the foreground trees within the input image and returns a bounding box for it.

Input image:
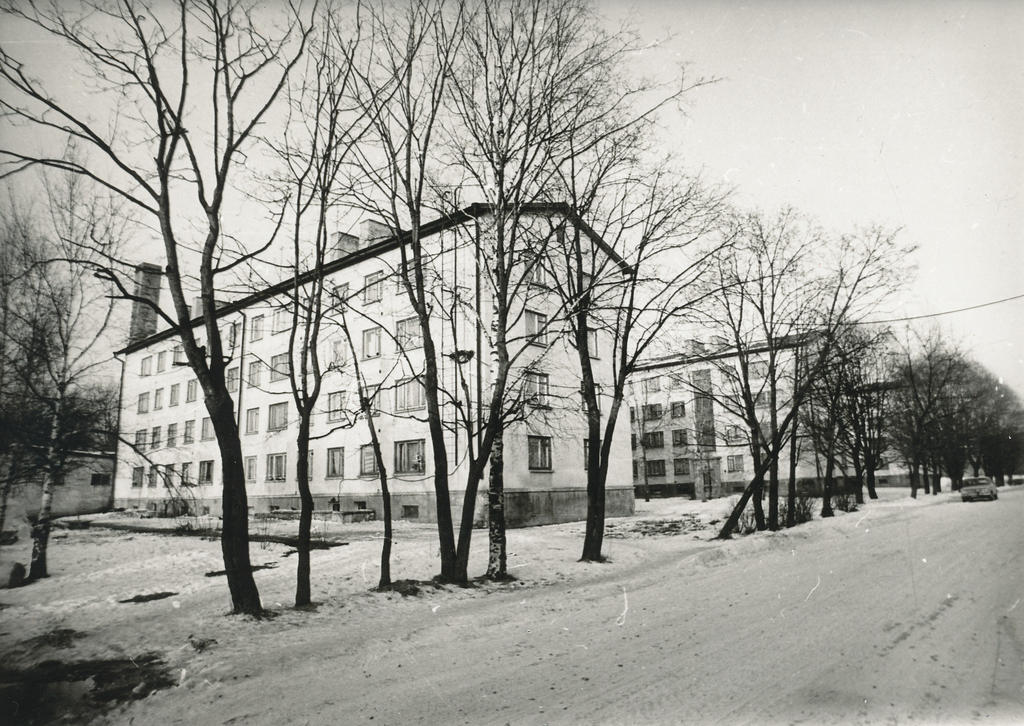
[115,205,633,526]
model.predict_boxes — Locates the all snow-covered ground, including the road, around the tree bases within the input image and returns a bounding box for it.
[0,489,1024,724]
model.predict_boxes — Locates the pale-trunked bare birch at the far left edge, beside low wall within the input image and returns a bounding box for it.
[3,173,127,581]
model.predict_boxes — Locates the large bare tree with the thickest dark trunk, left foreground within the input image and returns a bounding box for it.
[0,0,310,614]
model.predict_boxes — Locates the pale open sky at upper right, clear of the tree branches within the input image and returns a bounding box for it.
[602,0,1024,394]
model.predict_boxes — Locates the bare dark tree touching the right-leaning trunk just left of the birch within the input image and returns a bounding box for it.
[351,0,464,582]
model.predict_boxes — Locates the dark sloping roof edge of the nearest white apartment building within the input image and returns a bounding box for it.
[117,202,630,355]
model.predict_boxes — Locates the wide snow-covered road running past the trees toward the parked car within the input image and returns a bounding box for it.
[92,489,1024,726]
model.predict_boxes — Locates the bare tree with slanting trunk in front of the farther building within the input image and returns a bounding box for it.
[706,210,905,538]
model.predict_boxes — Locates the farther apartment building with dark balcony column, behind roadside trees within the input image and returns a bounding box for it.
[629,343,907,499]
